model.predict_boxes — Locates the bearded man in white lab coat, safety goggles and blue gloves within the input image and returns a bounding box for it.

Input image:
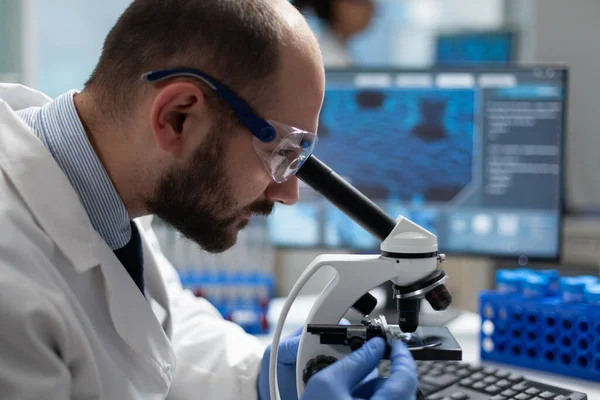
[0,0,417,400]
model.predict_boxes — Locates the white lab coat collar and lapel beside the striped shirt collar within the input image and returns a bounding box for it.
[0,84,100,272]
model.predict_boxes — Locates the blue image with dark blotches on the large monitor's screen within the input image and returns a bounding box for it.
[315,89,475,203]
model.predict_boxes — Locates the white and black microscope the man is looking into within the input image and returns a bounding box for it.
[270,155,462,399]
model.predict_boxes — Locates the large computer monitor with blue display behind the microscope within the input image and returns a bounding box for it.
[268,66,567,259]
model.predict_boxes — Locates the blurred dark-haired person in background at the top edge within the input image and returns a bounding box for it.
[293,0,375,68]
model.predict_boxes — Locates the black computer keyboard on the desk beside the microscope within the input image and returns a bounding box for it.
[379,361,587,400]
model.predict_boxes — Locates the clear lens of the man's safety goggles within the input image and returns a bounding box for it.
[254,121,318,183]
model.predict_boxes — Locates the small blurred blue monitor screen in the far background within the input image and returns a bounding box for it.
[435,31,515,67]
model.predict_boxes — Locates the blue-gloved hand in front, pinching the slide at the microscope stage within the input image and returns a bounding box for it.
[302,338,417,400]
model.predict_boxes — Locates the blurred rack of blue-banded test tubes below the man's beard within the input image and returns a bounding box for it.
[153,218,275,334]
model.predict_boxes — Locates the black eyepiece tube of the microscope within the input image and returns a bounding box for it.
[296,155,396,242]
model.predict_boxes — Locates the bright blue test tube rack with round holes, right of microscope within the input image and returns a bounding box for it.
[479,271,600,381]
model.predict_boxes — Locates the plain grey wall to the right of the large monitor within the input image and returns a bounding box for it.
[509,0,600,212]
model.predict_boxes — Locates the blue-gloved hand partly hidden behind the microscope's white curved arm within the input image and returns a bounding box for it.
[258,328,302,400]
